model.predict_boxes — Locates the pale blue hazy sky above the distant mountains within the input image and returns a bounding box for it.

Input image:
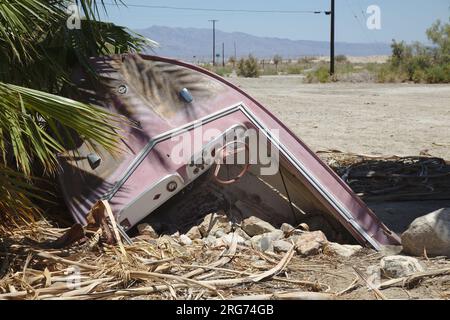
[102,0,450,42]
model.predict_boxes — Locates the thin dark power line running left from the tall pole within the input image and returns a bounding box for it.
[104,2,325,14]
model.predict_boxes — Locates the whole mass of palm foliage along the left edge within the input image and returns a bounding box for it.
[0,0,155,225]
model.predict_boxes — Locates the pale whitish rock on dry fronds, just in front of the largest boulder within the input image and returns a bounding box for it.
[380,256,425,278]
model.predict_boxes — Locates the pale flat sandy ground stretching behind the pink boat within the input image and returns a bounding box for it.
[231,76,450,160]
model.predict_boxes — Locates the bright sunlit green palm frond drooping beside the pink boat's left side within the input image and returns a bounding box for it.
[0,83,125,176]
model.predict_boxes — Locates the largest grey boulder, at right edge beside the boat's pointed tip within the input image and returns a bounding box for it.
[402,208,450,257]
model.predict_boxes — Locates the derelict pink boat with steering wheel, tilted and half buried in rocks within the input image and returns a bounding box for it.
[59,54,400,249]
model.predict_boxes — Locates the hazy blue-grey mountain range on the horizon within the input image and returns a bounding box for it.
[137,26,391,61]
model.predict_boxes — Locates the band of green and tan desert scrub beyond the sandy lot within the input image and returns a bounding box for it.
[205,17,450,84]
